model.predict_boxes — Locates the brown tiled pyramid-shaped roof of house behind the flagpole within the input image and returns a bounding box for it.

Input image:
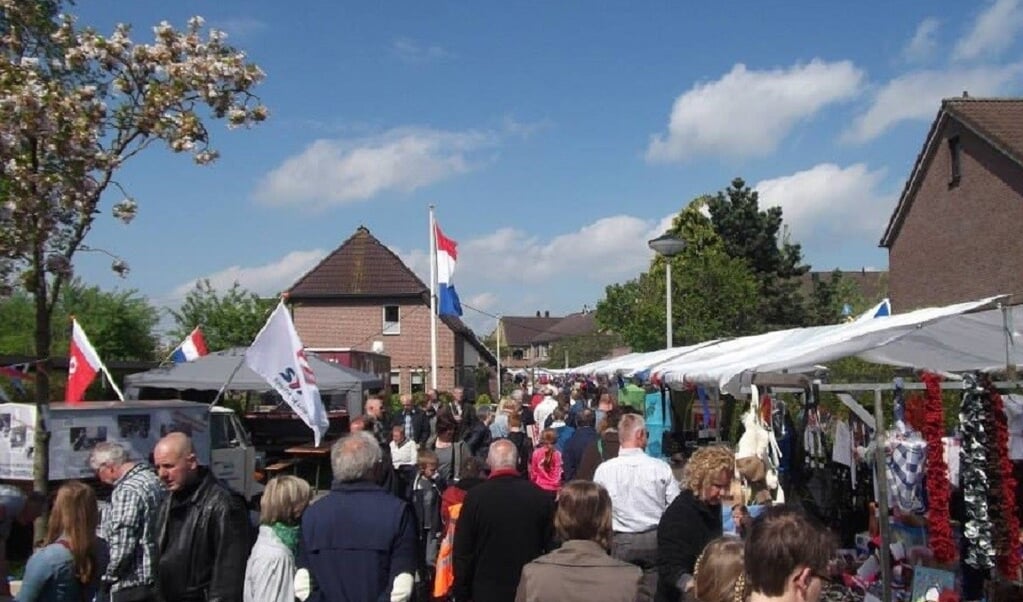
[287,226,430,299]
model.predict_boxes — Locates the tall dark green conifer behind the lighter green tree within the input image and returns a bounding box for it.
[707,178,809,331]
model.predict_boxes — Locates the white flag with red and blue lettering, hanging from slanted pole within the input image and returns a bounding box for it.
[246,301,328,446]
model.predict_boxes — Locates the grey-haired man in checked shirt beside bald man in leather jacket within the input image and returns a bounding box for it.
[89,441,165,602]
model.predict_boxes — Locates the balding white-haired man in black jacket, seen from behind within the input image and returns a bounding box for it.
[453,439,553,602]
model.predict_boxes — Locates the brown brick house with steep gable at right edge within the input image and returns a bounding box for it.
[881,96,1023,312]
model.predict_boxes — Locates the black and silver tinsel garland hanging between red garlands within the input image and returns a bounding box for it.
[960,376,994,570]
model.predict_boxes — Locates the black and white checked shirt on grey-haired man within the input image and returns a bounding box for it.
[99,463,165,592]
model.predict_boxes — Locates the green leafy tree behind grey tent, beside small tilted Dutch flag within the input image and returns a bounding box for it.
[170,280,277,351]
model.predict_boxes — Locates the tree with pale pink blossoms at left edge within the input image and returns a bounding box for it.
[0,0,267,528]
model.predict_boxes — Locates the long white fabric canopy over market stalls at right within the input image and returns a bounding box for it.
[571,296,1023,393]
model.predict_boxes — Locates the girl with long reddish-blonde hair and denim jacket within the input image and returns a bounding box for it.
[17,481,106,602]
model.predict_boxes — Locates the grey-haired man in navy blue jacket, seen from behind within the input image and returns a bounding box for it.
[299,431,416,602]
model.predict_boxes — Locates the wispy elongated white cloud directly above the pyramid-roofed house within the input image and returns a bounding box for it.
[255,128,496,207]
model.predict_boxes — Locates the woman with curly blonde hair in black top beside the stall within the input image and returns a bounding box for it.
[656,445,736,602]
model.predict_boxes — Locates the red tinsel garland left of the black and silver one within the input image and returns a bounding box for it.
[923,373,957,564]
